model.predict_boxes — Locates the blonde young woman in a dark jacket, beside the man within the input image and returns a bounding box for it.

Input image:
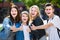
[29,5,46,40]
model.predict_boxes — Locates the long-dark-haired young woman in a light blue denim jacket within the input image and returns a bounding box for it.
[2,6,23,40]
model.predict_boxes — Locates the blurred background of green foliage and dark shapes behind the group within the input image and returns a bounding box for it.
[0,0,60,23]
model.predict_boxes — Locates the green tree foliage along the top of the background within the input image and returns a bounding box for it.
[0,0,60,8]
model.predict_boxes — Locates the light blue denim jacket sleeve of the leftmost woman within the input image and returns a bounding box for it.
[0,18,10,39]
